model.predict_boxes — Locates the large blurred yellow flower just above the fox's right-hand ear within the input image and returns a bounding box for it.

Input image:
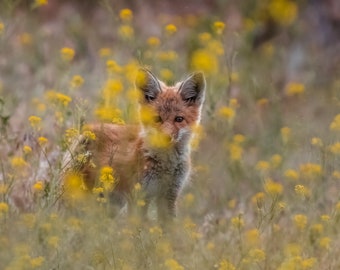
[190,49,218,75]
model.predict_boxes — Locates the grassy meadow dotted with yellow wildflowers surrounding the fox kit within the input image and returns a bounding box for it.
[0,0,340,270]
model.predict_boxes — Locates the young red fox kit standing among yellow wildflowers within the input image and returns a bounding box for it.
[63,69,205,219]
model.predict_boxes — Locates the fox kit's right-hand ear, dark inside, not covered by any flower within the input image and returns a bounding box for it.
[178,72,205,105]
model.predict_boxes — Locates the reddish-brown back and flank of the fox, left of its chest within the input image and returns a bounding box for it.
[83,123,144,191]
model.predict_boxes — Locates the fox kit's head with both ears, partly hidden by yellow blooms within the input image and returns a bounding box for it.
[136,69,205,146]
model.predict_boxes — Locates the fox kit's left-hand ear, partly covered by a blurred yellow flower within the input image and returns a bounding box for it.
[136,68,161,102]
